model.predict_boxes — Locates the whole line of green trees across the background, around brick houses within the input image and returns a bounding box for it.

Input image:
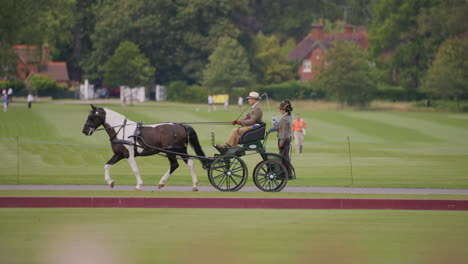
[0,0,468,105]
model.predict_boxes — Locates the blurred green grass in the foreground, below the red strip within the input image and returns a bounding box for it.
[0,209,468,264]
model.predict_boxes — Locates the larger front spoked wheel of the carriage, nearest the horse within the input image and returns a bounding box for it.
[208,155,248,192]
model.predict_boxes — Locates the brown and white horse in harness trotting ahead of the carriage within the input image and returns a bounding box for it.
[82,105,209,191]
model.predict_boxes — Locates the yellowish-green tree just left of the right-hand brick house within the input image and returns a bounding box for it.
[255,32,295,84]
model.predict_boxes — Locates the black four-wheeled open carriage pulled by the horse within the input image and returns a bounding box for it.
[207,123,296,192]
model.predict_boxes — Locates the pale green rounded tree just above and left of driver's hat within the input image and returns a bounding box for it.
[203,37,253,93]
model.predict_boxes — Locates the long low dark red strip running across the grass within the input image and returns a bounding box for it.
[0,197,468,211]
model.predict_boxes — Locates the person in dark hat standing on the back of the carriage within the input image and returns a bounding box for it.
[277,101,293,174]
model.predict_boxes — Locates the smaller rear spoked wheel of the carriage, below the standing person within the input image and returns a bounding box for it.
[253,160,288,192]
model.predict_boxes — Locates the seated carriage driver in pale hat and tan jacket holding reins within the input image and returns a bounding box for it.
[226,92,263,147]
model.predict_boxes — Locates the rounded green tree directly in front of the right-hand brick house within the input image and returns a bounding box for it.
[317,41,375,106]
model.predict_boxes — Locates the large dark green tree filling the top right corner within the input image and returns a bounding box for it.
[369,0,468,95]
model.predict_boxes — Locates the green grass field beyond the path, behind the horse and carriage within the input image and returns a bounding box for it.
[0,102,468,188]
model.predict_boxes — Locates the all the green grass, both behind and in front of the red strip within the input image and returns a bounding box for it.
[0,102,468,264]
